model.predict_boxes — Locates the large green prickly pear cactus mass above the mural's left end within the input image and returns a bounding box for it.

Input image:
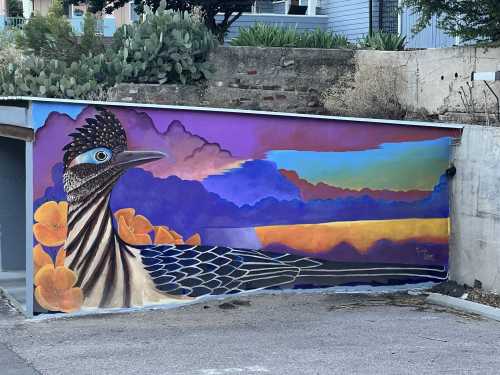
[0,8,217,100]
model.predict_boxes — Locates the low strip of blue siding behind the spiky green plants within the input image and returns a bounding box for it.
[217,14,328,40]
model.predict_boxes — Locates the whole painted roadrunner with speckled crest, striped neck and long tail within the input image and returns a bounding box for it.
[63,108,447,307]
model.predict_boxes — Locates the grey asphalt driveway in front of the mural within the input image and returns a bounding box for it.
[0,294,500,375]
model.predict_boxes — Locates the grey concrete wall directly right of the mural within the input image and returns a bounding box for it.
[450,125,500,293]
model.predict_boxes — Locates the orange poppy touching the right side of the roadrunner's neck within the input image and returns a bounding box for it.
[115,208,153,245]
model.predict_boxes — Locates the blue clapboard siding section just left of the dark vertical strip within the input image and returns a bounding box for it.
[321,0,375,42]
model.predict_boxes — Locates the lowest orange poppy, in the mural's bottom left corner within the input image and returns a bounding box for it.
[34,264,83,312]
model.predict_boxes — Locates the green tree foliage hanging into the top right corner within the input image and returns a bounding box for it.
[403,0,500,42]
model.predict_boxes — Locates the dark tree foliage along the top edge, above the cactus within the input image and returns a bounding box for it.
[73,0,254,42]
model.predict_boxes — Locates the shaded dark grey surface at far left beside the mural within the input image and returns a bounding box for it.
[0,137,26,270]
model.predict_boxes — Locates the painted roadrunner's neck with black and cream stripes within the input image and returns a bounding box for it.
[65,179,134,307]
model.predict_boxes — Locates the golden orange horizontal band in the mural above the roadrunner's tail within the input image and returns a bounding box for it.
[256,218,449,254]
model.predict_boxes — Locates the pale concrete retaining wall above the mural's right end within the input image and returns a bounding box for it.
[340,47,500,118]
